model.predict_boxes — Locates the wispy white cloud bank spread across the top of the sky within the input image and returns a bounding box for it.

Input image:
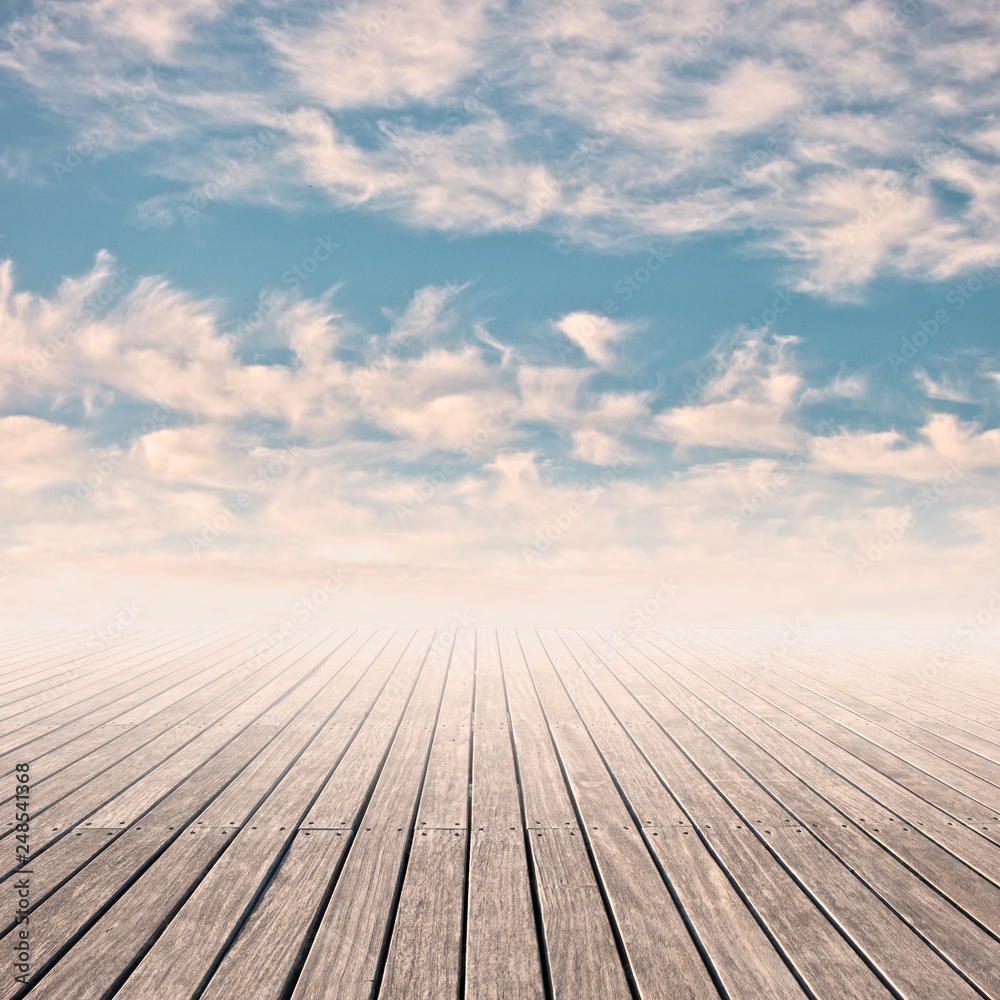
[0,0,1000,297]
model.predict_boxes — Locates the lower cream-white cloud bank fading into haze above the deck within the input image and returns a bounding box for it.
[0,254,1000,625]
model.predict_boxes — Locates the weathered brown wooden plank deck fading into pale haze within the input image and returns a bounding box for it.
[0,630,1000,1000]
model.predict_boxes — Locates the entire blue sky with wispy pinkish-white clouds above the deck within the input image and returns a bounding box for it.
[0,0,1000,635]
